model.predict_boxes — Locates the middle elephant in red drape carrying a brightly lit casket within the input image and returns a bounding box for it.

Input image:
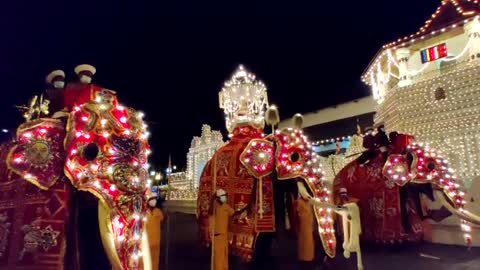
[197,67,362,268]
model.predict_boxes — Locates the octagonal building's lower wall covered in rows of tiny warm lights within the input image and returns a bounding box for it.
[377,62,480,181]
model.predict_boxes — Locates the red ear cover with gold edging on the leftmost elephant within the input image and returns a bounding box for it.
[7,119,65,190]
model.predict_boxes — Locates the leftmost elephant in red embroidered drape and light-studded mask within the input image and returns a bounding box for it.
[0,70,151,270]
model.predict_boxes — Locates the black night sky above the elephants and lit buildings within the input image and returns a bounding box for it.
[0,0,440,169]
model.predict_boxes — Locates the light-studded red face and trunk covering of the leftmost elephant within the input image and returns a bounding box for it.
[65,92,151,269]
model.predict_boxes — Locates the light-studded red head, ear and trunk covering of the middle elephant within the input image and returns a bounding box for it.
[236,125,336,257]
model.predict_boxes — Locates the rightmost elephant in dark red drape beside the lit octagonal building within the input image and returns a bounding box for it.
[334,129,480,246]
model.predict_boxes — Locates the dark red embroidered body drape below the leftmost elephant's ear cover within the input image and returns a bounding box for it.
[0,143,71,270]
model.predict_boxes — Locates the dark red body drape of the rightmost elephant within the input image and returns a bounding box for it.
[334,155,423,242]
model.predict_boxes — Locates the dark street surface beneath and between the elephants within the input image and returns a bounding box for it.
[160,213,480,270]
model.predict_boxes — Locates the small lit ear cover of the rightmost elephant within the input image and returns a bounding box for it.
[382,155,412,187]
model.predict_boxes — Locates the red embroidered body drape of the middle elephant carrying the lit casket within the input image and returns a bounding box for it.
[198,126,275,261]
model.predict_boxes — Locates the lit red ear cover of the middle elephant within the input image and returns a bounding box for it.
[240,139,275,178]
